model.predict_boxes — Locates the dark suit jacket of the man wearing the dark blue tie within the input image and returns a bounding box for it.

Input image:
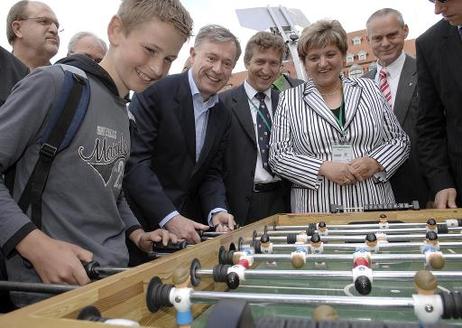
[220,84,288,225]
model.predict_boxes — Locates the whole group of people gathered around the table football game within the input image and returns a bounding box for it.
[0,0,462,308]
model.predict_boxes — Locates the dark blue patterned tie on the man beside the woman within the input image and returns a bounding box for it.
[255,92,273,174]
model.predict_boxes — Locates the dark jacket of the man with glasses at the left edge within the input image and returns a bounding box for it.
[0,47,29,106]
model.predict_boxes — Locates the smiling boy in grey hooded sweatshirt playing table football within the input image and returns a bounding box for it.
[0,0,192,306]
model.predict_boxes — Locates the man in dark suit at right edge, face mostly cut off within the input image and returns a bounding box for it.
[416,0,462,208]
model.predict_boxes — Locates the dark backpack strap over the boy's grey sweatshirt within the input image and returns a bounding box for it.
[18,68,89,229]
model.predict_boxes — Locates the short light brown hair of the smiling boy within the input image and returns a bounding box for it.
[117,0,193,39]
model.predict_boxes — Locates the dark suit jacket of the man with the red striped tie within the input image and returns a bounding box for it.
[364,55,430,207]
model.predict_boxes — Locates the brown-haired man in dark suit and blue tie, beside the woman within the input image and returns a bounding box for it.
[220,32,288,225]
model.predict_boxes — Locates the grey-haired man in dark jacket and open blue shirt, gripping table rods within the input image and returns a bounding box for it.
[124,25,241,242]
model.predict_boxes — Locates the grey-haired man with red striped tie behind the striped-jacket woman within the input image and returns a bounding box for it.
[365,8,430,207]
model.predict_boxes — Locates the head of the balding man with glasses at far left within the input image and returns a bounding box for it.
[6,1,60,69]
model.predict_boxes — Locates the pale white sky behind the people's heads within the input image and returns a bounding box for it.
[0,0,441,74]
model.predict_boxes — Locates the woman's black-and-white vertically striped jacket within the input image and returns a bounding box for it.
[270,77,410,212]
